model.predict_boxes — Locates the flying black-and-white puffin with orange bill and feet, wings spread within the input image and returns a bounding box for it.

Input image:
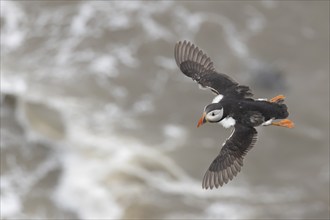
[174,40,294,189]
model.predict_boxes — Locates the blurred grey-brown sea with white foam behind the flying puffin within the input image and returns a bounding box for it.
[0,1,329,219]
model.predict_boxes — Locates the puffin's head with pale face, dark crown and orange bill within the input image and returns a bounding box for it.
[197,103,224,127]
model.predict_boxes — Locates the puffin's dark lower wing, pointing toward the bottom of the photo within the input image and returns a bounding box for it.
[202,124,257,189]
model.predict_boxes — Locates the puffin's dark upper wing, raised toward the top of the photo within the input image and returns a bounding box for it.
[174,41,252,97]
